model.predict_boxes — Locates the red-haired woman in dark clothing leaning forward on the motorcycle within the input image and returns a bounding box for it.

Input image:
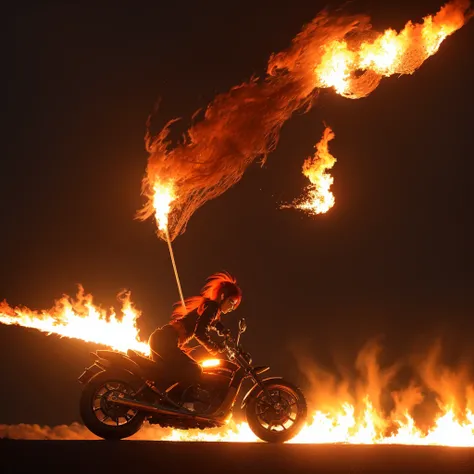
[149,272,242,394]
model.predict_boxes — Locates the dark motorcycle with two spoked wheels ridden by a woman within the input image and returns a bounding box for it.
[78,318,307,443]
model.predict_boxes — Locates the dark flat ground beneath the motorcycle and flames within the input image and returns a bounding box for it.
[0,439,474,474]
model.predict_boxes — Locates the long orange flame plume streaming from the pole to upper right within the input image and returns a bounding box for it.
[137,0,470,240]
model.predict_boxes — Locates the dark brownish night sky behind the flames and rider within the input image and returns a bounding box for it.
[0,0,474,425]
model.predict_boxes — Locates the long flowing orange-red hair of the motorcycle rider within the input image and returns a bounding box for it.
[171,272,242,321]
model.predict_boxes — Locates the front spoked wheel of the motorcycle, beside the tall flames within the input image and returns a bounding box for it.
[246,380,307,443]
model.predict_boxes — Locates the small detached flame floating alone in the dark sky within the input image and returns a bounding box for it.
[282,127,336,214]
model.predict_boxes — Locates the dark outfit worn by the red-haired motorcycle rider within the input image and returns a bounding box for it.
[149,300,220,385]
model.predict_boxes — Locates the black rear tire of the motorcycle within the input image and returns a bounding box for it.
[80,370,145,440]
